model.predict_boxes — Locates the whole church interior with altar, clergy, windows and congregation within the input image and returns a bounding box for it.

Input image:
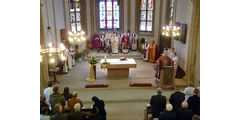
[40,0,200,120]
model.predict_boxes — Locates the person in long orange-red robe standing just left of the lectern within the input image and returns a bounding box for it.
[149,41,158,63]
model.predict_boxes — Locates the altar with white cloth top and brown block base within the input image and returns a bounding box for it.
[101,58,137,78]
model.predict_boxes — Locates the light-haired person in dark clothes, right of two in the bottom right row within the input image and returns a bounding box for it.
[177,101,193,120]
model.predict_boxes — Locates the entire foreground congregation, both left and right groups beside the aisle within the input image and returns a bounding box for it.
[40,81,200,120]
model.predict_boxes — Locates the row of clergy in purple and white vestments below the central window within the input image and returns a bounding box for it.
[92,31,137,54]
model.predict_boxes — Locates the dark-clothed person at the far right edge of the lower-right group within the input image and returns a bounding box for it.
[187,89,200,116]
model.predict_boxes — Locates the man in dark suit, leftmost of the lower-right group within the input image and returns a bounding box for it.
[150,88,166,118]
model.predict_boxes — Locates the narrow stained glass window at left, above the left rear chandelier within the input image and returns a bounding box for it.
[69,0,82,32]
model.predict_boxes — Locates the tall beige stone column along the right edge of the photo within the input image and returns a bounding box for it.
[186,0,200,87]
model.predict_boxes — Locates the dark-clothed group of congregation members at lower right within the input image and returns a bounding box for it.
[149,84,200,120]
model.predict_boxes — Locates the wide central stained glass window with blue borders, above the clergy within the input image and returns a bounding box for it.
[99,0,119,29]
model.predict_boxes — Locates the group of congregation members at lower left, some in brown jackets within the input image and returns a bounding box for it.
[40,81,106,120]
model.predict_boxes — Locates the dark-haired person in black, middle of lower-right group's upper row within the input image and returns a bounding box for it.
[169,88,185,112]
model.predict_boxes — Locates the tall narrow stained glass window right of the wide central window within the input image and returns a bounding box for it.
[140,0,153,32]
